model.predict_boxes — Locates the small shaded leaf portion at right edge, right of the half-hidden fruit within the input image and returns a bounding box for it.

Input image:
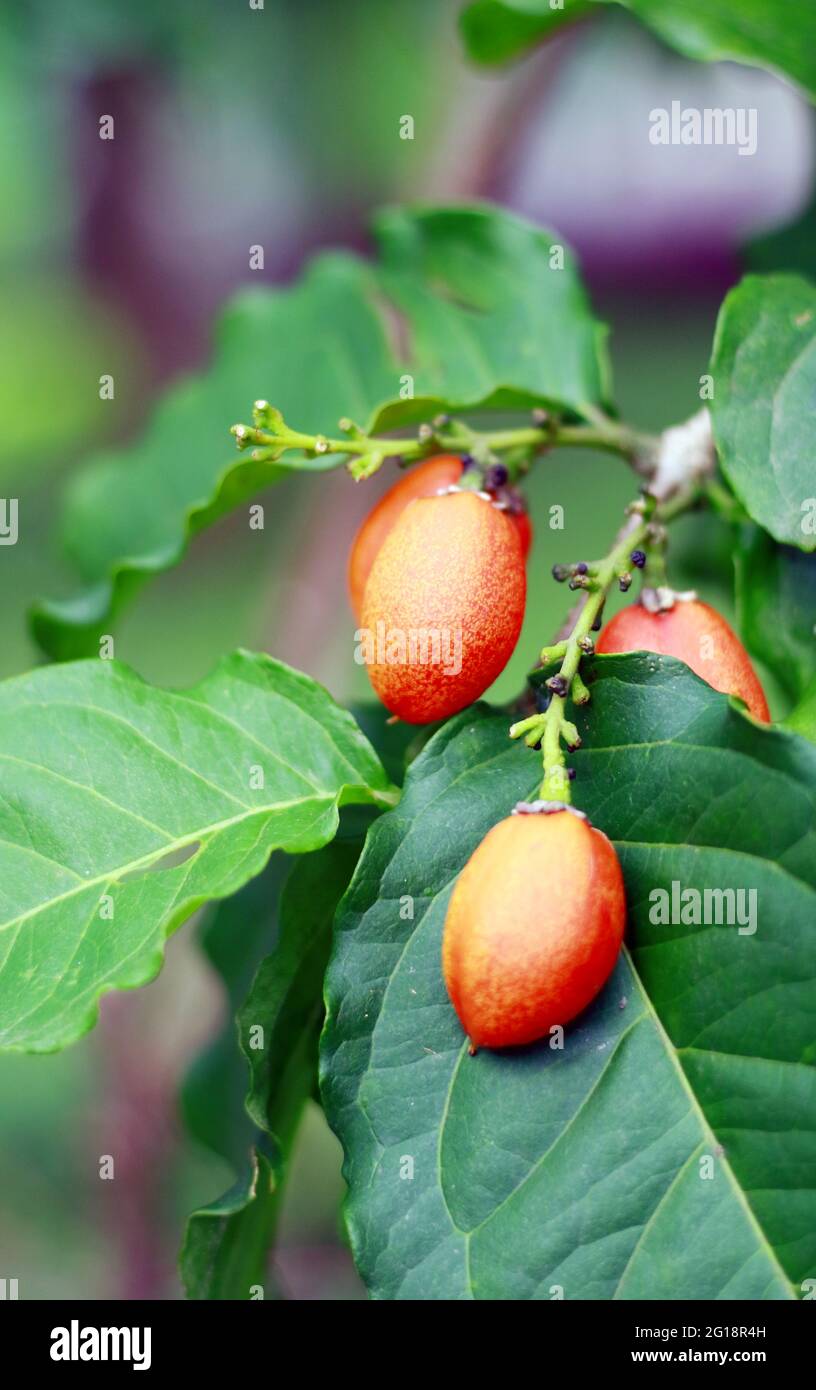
[734,525,816,701]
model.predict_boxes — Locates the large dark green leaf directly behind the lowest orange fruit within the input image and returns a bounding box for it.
[323,653,816,1300]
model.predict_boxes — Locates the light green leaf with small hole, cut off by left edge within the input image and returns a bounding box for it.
[0,652,396,1051]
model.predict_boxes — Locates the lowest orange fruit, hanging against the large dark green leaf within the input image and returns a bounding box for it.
[442,810,626,1052]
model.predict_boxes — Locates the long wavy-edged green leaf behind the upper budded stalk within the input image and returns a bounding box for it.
[32,207,607,660]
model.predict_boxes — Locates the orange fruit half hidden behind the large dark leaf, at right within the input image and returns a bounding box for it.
[595,599,770,724]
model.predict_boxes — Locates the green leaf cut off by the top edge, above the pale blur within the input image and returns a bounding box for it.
[462,0,816,96]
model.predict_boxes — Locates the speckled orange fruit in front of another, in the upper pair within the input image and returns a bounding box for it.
[360,492,527,724]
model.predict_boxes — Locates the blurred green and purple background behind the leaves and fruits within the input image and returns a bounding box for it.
[0,0,815,1298]
